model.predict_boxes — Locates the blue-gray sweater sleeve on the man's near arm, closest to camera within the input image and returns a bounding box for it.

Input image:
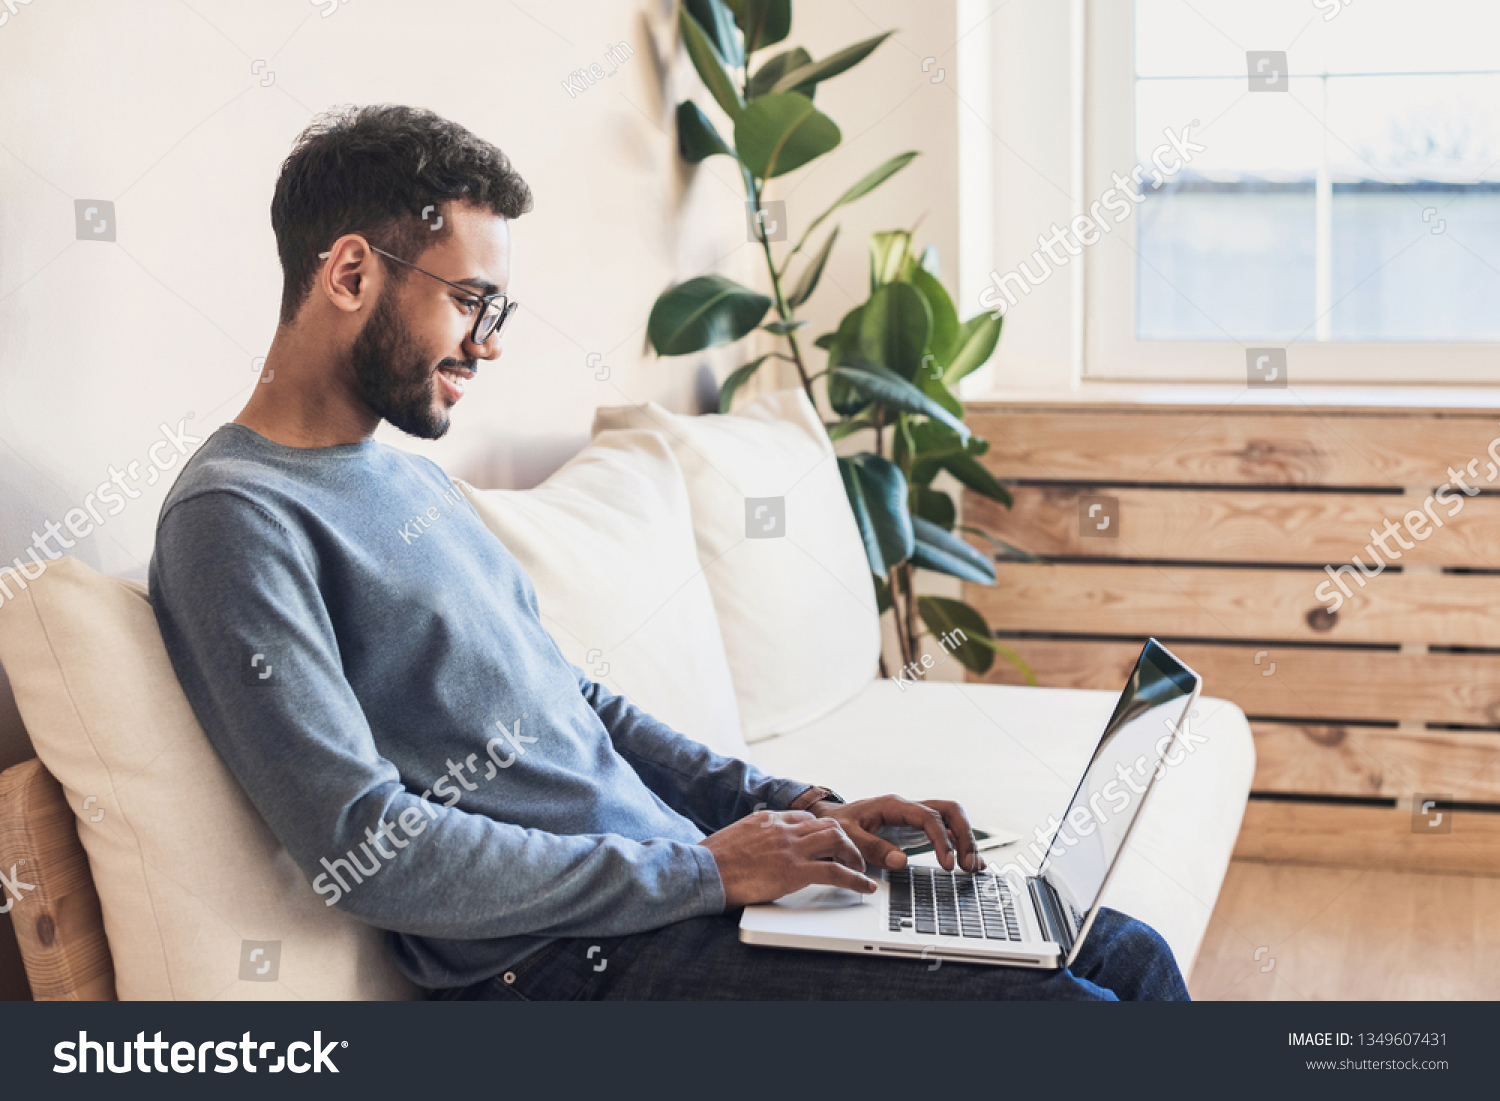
[150,491,725,939]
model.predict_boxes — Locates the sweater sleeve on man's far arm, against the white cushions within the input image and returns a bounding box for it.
[573,666,807,833]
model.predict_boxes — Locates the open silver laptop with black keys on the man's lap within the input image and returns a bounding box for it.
[740,639,1203,969]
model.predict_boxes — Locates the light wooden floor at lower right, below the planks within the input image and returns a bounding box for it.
[1188,860,1500,1001]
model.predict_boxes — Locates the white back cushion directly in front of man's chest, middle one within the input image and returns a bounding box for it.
[470,431,746,758]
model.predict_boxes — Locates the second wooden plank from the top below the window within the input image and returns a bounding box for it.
[963,486,1500,569]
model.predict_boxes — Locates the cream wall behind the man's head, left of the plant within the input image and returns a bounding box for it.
[0,0,756,588]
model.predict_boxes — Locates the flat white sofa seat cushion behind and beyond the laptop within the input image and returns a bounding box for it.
[752,681,1256,975]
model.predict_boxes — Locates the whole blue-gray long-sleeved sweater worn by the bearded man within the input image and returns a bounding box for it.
[150,423,807,987]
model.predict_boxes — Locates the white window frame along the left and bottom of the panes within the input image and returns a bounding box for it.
[1073,0,1500,384]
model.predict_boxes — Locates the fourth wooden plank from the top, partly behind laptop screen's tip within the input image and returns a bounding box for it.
[968,639,1500,726]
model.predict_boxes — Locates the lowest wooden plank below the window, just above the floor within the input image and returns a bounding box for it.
[1235,800,1500,876]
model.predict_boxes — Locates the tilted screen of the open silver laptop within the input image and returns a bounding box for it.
[1043,639,1199,933]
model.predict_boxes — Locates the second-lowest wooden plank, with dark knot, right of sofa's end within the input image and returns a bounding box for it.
[1250,723,1500,806]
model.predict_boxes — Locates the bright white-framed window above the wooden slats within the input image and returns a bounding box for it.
[1085,0,1500,383]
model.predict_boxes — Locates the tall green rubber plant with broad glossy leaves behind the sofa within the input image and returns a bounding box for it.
[648,0,1035,684]
